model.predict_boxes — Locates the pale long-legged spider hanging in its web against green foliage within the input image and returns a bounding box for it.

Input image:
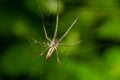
[37,0,81,64]
